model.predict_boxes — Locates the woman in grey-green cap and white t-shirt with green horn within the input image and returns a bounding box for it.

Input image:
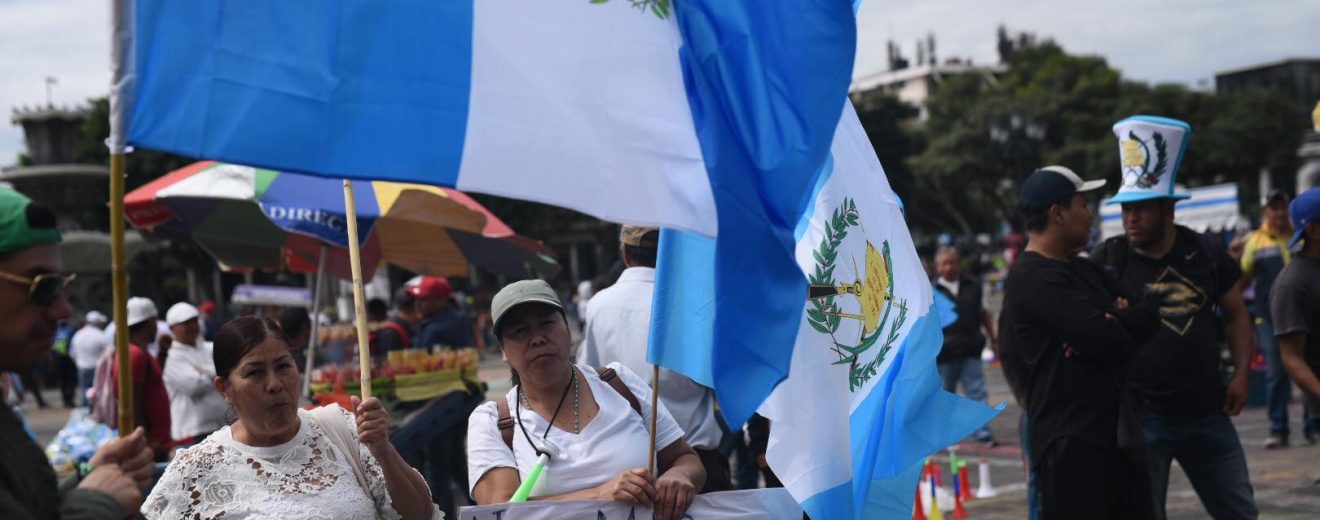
[467,280,706,519]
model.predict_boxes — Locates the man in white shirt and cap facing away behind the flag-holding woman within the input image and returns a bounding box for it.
[578,226,733,492]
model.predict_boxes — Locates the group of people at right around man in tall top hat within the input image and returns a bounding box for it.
[998,116,1320,519]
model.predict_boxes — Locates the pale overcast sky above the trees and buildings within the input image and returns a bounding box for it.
[0,0,1320,165]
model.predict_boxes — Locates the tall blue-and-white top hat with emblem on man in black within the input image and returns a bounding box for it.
[1107,116,1192,205]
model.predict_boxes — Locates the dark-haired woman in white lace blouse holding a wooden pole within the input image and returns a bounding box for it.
[143,318,442,520]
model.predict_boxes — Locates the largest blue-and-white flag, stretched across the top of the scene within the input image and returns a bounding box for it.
[110,0,857,418]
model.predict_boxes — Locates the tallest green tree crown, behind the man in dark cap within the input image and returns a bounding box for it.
[911,38,1119,235]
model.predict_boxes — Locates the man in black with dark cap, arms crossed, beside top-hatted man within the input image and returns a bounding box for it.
[999,166,1158,519]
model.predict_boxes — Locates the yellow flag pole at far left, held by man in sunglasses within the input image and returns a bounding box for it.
[110,153,136,437]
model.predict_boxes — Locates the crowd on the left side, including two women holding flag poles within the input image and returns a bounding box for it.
[0,189,775,519]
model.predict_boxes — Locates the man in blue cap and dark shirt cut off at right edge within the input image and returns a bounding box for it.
[1270,187,1320,432]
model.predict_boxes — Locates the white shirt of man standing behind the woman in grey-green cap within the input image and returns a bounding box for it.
[577,267,723,450]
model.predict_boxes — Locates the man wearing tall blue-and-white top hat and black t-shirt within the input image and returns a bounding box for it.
[1090,116,1257,519]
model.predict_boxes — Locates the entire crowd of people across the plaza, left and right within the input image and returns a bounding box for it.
[0,113,1320,519]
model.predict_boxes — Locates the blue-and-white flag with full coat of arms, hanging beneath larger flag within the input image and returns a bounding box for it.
[651,107,1002,519]
